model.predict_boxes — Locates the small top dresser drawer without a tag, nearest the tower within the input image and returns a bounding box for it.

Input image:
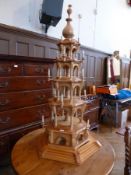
[24,63,49,76]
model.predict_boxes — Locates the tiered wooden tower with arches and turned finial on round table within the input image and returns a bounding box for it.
[42,5,99,164]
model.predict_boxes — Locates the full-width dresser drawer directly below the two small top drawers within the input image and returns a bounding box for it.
[0,76,51,93]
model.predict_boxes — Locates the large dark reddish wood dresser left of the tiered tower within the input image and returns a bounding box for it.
[0,55,54,159]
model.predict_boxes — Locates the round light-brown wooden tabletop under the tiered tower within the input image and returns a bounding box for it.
[12,129,115,175]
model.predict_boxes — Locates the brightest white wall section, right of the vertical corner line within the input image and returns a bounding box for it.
[95,0,131,56]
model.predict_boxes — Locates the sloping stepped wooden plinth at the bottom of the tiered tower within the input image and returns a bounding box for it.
[42,137,101,165]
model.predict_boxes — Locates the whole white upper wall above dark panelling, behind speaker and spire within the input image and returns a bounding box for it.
[0,0,131,57]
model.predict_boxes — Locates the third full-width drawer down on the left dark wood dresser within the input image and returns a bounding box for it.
[0,104,51,131]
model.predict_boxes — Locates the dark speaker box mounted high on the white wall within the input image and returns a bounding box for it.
[39,0,63,33]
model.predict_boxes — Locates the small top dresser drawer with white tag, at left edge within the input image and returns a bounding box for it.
[0,61,23,76]
